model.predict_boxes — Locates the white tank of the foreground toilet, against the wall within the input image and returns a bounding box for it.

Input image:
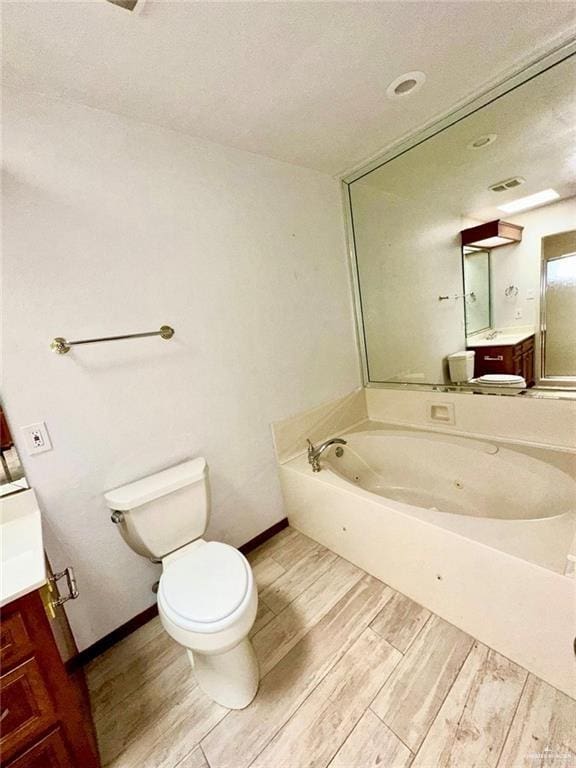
[104,458,210,560]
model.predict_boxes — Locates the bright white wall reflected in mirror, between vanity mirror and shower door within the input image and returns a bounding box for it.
[490,197,576,328]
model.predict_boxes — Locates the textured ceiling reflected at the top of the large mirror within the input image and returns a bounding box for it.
[352,55,576,221]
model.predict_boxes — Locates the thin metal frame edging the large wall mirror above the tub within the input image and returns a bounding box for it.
[340,38,576,399]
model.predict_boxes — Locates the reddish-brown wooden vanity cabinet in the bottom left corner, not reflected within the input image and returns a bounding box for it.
[0,590,100,768]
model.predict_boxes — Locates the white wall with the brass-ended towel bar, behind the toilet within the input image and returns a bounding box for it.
[2,91,360,648]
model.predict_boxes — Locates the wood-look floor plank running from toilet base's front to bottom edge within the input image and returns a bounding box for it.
[107,686,229,768]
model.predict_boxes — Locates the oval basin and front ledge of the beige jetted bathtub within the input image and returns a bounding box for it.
[323,430,576,573]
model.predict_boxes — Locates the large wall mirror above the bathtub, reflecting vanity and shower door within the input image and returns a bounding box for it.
[347,55,576,394]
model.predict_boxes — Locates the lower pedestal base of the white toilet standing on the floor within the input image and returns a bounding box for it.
[187,638,260,709]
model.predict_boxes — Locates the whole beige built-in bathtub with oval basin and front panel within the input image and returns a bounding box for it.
[280,426,576,696]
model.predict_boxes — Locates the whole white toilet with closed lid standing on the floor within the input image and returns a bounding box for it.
[104,458,259,709]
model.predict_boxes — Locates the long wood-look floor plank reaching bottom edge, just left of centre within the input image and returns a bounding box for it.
[251,629,402,768]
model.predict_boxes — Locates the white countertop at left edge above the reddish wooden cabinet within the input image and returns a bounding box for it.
[0,488,46,606]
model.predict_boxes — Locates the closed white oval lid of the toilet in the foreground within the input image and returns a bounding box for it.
[160,541,249,624]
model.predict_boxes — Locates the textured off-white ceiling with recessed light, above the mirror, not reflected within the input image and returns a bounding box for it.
[2,0,576,174]
